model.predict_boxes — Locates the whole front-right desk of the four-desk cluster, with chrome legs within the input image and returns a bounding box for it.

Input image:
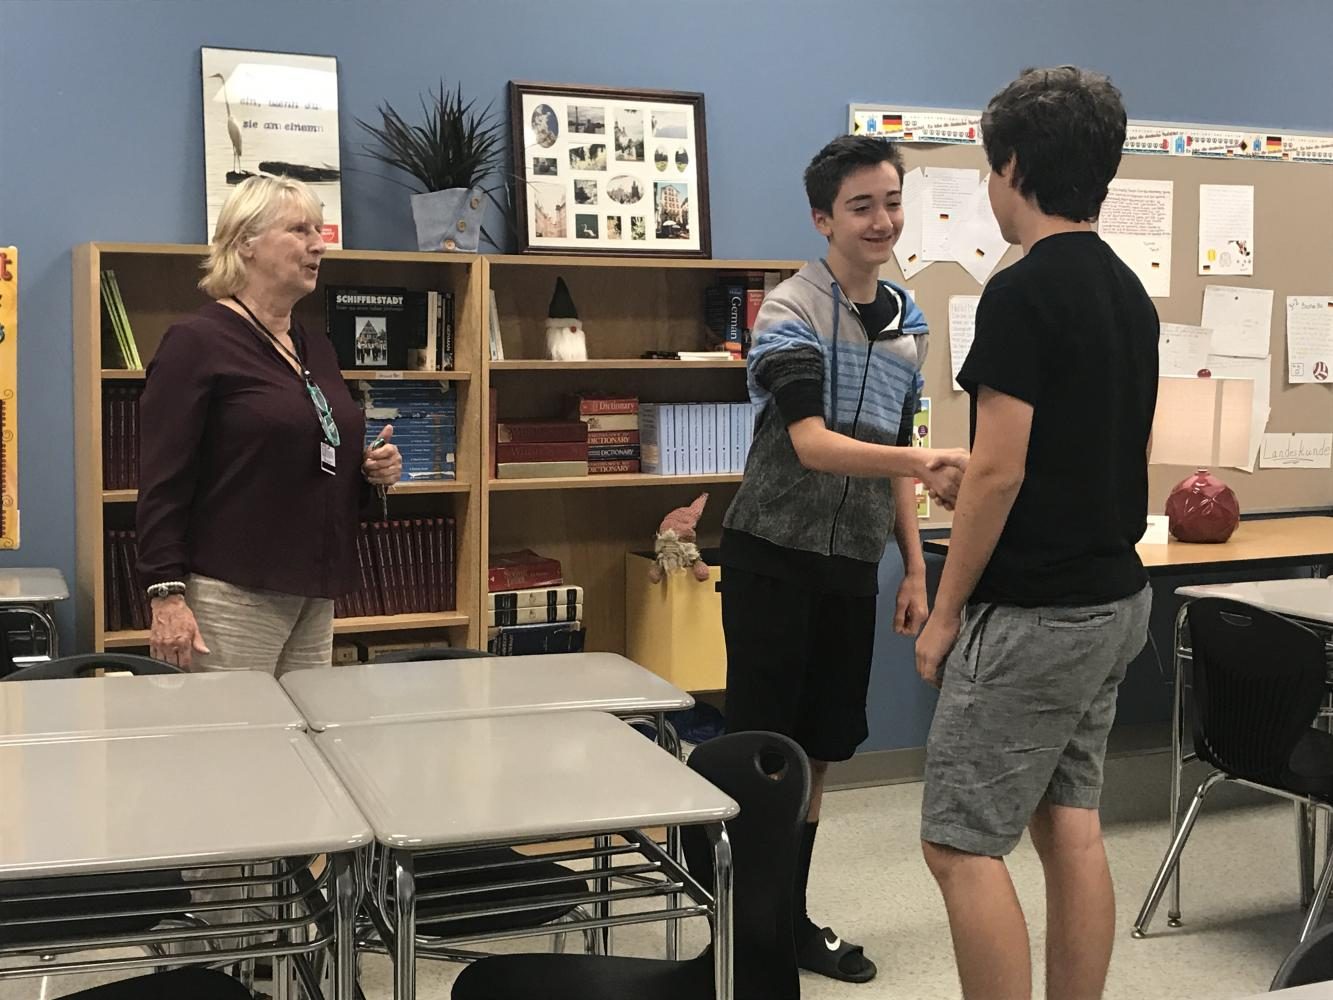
[316,714,737,1000]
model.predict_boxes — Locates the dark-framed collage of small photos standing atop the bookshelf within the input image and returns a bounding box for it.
[509,80,712,257]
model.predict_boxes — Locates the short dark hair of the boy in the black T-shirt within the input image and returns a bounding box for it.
[981,65,1125,223]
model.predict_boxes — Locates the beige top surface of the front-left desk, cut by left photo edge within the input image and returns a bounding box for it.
[0,729,371,880]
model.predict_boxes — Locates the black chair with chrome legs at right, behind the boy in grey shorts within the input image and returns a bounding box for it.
[1134,597,1333,941]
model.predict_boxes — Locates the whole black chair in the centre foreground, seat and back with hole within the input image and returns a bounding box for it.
[452,732,810,1000]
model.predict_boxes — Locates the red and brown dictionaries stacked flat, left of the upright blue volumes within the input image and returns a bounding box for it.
[491,389,640,479]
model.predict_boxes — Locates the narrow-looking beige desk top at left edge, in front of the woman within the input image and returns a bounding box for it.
[0,671,305,743]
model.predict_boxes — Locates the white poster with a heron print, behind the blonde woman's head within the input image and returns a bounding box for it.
[200,48,343,247]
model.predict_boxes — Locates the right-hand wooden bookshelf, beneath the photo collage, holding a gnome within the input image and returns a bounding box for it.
[477,255,804,653]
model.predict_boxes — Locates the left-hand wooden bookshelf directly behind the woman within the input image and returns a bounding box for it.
[73,243,485,651]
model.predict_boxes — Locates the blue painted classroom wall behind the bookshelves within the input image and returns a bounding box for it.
[0,0,1333,748]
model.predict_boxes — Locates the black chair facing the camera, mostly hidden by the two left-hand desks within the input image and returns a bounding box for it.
[0,653,191,944]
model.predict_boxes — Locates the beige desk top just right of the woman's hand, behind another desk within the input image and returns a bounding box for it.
[283,653,694,732]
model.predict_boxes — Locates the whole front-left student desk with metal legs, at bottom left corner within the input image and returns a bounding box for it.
[0,725,372,1000]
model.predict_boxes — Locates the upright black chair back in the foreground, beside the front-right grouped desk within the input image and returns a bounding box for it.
[681,732,810,1000]
